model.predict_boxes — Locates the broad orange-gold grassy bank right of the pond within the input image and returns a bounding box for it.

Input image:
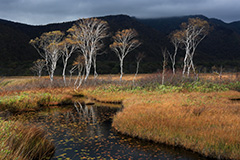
[84,84,240,159]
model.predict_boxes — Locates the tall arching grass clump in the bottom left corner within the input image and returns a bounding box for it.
[0,119,55,160]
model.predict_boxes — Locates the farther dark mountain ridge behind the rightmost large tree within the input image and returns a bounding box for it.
[139,15,240,67]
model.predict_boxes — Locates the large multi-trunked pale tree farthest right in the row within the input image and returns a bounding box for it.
[174,18,210,76]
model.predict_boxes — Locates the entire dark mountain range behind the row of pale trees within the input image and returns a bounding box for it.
[0,15,240,76]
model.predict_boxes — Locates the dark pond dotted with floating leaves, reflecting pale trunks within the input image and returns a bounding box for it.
[13,102,210,160]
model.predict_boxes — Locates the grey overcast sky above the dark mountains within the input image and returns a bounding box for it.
[0,0,240,25]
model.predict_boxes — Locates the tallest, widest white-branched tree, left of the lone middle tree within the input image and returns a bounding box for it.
[68,18,108,81]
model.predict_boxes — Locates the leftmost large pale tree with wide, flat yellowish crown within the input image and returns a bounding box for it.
[30,31,64,82]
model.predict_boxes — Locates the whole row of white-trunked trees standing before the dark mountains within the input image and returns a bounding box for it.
[30,18,210,89]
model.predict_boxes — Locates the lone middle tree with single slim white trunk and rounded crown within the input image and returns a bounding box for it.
[110,29,141,81]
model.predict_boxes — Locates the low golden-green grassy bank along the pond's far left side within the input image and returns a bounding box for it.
[0,89,73,113]
